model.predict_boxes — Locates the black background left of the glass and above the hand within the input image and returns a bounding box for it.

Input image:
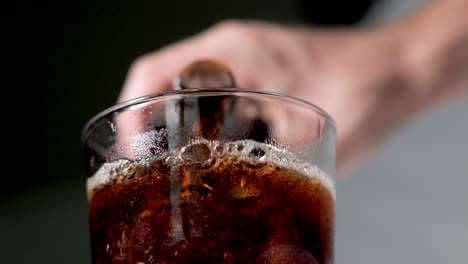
[0,0,371,263]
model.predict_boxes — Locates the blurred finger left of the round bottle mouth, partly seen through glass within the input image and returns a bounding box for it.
[116,34,238,159]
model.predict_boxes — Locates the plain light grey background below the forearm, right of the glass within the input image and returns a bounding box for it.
[336,103,468,264]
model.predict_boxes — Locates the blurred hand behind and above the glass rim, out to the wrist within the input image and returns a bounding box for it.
[119,11,466,174]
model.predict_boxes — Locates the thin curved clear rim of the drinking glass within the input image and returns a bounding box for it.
[81,88,336,143]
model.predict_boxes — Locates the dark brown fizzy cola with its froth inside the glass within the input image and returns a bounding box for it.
[87,140,335,264]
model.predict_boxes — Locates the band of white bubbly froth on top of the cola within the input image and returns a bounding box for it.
[87,139,336,198]
